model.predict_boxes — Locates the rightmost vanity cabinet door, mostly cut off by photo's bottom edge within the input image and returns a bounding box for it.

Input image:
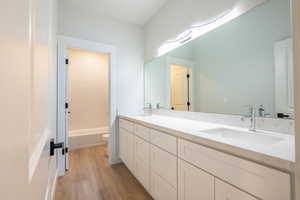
[216,179,258,200]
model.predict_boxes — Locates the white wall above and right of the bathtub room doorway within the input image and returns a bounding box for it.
[58,0,144,114]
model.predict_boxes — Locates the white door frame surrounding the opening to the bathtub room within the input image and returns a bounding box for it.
[57,36,119,176]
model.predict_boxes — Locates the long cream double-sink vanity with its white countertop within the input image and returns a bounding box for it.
[119,115,294,200]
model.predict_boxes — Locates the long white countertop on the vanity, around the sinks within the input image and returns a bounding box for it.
[120,115,295,172]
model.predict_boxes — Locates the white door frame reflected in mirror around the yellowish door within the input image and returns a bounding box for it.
[166,56,195,112]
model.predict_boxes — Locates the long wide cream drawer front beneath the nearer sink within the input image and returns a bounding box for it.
[178,139,291,200]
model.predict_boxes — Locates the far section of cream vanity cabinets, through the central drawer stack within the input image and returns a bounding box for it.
[119,119,177,200]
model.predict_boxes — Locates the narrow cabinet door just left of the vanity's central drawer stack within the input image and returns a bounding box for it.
[134,137,150,191]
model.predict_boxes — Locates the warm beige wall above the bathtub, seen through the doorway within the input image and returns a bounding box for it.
[68,49,109,133]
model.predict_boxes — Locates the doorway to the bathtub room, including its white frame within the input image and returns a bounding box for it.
[57,36,119,176]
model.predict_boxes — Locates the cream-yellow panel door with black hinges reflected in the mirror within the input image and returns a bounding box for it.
[171,65,189,111]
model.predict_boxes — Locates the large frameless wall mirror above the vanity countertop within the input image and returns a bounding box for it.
[144,0,294,118]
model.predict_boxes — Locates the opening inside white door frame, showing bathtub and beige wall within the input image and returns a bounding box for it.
[66,48,109,150]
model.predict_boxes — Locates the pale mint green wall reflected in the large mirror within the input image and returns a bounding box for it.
[193,0,291,114]
